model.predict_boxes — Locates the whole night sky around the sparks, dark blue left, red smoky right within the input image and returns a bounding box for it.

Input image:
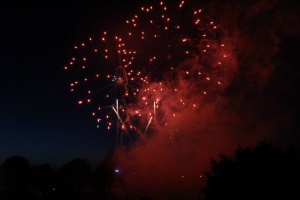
[0,0,300,198]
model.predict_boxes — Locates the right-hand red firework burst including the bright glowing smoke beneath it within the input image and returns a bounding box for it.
[122,1,228,129]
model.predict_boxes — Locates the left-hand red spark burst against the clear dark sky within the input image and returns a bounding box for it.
[65,32,147,142]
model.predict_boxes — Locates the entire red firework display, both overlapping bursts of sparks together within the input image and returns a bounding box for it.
[65,1,229,144]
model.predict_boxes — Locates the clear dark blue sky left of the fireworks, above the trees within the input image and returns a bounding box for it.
[0,1,138,166]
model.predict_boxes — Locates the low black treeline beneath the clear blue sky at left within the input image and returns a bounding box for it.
[0,149,117,200]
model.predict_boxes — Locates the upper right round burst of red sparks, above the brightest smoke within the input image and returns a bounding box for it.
[123,1,226,84]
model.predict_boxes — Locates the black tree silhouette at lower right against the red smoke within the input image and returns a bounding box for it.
[203,141,300,200]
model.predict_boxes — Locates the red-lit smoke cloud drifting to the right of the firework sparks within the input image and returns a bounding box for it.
[110,0,300,199]
